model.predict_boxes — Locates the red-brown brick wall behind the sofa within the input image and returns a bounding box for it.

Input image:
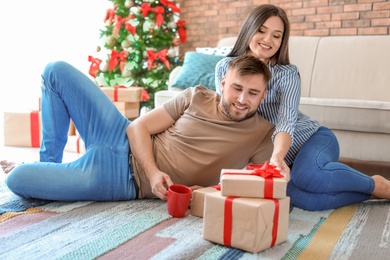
[177,0,390,53]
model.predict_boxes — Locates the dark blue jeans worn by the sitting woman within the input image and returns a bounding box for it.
[287,127,375,210]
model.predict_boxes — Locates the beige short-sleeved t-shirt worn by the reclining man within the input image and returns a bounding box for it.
[133,86,274,198]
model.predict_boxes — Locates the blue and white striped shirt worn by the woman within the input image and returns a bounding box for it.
[215,57,320,165]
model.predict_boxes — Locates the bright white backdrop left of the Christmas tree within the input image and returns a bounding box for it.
[0,0,112,112]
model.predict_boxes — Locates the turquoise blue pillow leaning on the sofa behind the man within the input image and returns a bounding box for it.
[171,52,224,91]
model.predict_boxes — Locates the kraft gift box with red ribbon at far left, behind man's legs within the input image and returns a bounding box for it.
[4,110,42,148]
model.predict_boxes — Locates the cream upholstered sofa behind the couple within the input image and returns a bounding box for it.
[155,35,390,174]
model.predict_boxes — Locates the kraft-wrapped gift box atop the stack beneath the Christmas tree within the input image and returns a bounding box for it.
[101,87,143,102]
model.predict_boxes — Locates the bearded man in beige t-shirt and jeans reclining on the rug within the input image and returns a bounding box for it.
[3,56,289,201]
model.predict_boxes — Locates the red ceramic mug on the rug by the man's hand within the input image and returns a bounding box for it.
[167,184,192,218]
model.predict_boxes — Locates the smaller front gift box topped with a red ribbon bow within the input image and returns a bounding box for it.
[221,162,287,199]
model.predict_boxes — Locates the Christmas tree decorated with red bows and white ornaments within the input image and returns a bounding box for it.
[89,0,186,107]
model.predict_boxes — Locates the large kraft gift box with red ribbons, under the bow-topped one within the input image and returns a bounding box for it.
[203,192,290,253]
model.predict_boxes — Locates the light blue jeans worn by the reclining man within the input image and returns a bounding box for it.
[6,62,136,201]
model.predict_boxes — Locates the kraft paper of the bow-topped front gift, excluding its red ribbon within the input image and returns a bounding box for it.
[221,169,287,199]
